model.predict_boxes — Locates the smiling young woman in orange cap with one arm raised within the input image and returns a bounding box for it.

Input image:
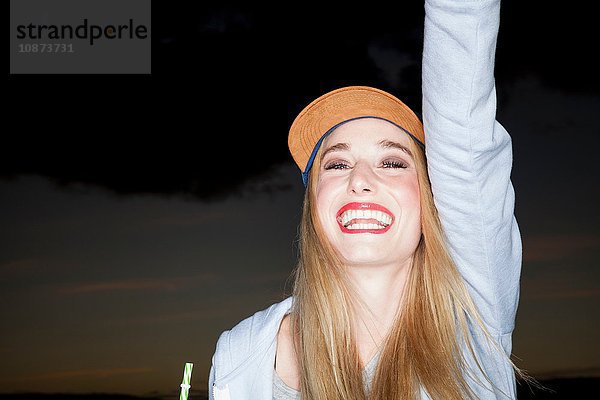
[209,0,527,400]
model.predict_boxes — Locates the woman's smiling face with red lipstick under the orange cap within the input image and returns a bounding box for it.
[316,118,421,266]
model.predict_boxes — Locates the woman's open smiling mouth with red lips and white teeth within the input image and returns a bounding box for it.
[337,203,394,234]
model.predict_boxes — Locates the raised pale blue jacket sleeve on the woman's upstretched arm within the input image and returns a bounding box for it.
[422,0,522,335]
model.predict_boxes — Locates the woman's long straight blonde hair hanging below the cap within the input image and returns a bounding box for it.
[290,129,534,400]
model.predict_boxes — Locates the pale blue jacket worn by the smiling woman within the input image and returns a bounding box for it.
[209,0,522,400]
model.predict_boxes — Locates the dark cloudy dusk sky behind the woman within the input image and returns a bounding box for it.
[0,0,600,394]
